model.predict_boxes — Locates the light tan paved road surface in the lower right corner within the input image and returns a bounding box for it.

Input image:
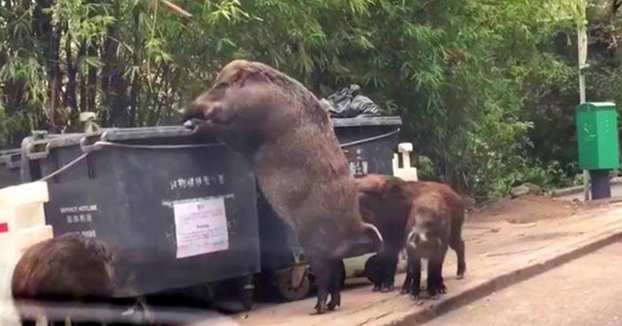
[425,239,622,326]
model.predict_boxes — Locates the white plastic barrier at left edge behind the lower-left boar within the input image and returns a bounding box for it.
[0,182,53,326]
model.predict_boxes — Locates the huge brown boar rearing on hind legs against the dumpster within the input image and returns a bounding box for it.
[181,60,382,313]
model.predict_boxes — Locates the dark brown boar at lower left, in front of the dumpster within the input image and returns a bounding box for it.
[11,233,114,326]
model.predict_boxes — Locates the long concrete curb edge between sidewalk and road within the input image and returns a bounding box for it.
[379,216,622,326]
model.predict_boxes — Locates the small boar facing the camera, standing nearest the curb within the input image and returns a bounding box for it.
[402,182,466,298]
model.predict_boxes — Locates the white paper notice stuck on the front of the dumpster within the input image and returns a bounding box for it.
[173,197,229,258]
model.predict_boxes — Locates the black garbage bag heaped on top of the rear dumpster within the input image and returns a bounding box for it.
[321,85,380,118]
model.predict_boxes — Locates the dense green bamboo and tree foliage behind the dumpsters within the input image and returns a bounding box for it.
[0,0,606,195]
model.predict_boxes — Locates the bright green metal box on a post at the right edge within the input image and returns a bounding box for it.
[576,102,620,170]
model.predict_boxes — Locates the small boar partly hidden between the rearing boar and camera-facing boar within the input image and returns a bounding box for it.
[356,174,413,292]
